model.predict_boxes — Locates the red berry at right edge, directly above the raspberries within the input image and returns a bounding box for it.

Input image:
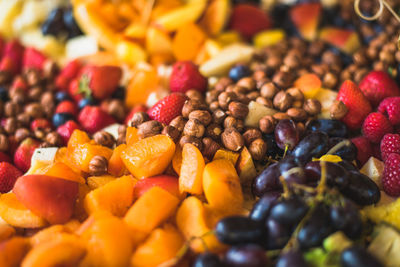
[359,71,400,107]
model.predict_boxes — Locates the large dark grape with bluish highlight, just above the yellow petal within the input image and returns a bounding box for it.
[291,132,329,165]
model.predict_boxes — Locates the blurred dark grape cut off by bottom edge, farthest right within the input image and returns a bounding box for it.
[340,246,384,267]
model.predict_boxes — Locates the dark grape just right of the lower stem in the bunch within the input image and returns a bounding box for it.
[297,205,332,249]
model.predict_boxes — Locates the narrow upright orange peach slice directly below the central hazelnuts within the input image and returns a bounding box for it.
[179,144,205,195]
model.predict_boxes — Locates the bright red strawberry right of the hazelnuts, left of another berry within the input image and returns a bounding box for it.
[336,80,372,130]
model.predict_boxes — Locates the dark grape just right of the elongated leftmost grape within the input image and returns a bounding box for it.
[264,219,291,250]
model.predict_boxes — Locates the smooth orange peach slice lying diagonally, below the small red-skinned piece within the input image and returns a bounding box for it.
[124,186,179,233]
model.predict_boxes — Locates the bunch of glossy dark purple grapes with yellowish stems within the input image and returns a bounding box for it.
[194,120,382,267]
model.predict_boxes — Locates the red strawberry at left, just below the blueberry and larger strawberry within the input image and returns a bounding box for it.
[78,106,115,134]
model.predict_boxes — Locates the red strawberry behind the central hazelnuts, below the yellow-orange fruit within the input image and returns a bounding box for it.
[169,61,208,93]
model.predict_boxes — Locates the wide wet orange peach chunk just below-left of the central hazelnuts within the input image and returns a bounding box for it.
[121,135,175,179]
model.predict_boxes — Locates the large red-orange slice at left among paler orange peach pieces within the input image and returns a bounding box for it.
[13,174,78,224]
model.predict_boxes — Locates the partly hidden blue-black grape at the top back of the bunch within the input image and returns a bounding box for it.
[307,119,348,137]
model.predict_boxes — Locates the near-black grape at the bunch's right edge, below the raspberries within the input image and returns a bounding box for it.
[339,171,381,206]
